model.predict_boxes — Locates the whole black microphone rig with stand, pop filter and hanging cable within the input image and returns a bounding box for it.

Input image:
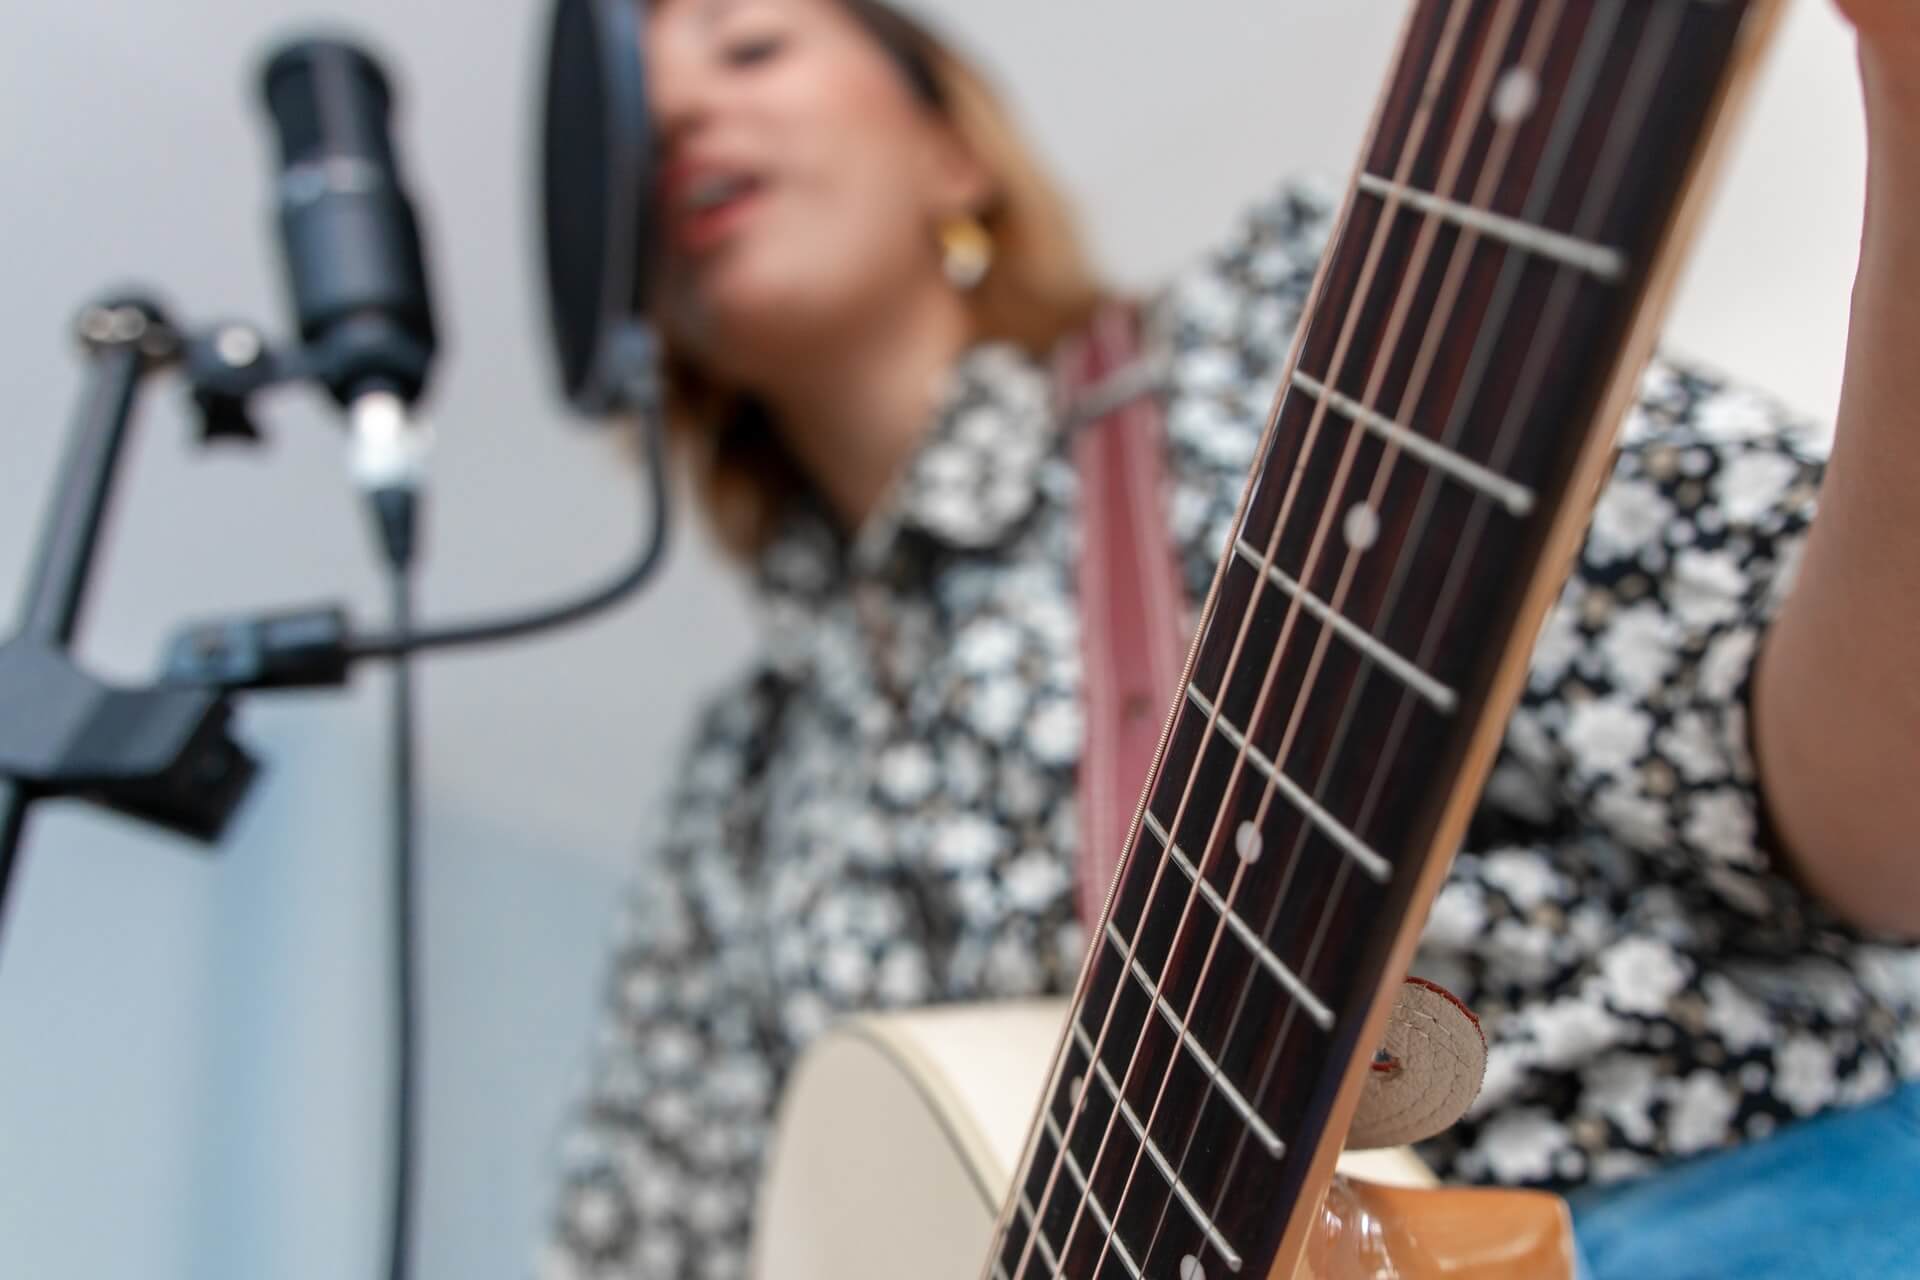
[0,27,670,1280]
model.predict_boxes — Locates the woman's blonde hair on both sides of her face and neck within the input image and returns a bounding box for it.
[664,0,1100,557]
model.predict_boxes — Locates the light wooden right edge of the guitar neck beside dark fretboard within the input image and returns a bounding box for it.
[1267,0,1786,1280]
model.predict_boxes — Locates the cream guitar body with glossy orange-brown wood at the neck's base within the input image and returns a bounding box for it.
[753,1000,1572,1280]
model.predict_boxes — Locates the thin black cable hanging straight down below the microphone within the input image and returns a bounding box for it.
[386,564,419,1280]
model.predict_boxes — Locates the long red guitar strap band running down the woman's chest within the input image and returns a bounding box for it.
[1056,305,1187,929]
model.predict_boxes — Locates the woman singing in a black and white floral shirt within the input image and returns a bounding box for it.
[545,0,1920,1280]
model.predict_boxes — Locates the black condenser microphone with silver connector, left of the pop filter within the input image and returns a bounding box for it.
[261,38,438,562]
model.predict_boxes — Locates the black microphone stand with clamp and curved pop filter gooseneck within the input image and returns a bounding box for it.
[0,282,668,959]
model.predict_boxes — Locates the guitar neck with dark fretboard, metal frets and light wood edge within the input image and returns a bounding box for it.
[998,0,1784,1280]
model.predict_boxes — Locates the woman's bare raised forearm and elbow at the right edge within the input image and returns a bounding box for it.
[1753,12,1920,935]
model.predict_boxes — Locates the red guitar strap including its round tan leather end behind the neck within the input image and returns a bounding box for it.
[1054,303,1486,1150]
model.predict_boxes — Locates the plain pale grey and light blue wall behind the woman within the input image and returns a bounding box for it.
[0,0,1864,1280]
